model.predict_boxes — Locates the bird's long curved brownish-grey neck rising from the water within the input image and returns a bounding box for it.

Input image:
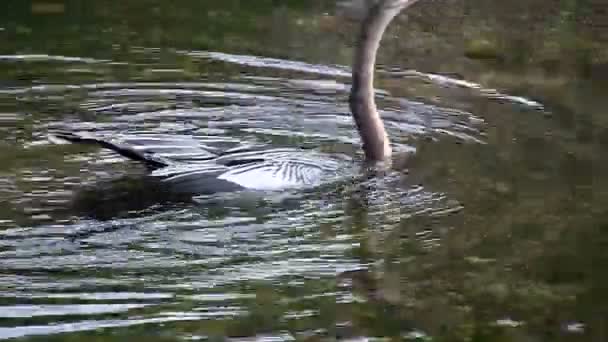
[349,0,418,161]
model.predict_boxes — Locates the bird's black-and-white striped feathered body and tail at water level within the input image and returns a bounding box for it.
[57,133,354,194]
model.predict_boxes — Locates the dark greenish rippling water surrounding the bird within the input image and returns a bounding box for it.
[0,1,608,341]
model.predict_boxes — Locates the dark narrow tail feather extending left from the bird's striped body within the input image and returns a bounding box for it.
[50,131,168,169]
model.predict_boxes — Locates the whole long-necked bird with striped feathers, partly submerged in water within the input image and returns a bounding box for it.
[51,0,417,194]
